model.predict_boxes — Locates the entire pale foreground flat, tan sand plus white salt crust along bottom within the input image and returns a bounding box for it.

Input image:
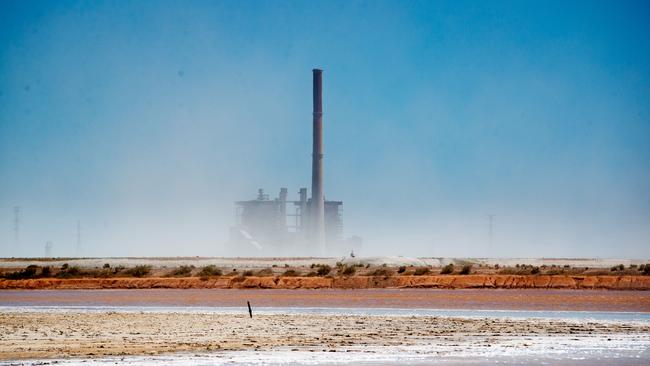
[0,308,650,364]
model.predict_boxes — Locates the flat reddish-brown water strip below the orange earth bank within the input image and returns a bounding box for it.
[0,289,650,313]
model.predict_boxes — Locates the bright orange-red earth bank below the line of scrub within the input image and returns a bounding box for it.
[0,275,650,290]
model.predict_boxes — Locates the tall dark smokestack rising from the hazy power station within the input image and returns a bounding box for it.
[310,69,325,254]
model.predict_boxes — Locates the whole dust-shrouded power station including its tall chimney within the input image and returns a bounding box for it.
[230,69,361,255]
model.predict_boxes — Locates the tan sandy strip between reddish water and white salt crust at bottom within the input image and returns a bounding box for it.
[0,312,650,361]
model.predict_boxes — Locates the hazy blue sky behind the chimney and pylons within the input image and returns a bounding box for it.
[0,0,650,258]
